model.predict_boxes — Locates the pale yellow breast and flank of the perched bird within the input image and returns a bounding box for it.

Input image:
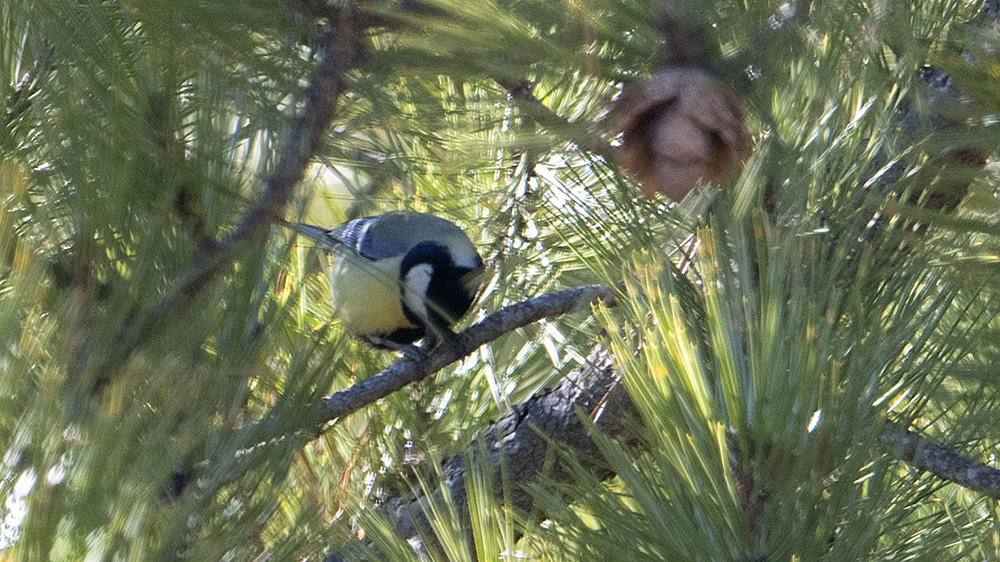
[330,255,416,335]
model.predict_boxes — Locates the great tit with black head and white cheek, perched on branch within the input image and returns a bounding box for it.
[297,211,486,352]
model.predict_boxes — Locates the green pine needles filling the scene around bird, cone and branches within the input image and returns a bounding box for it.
[0,0,1000,562]
